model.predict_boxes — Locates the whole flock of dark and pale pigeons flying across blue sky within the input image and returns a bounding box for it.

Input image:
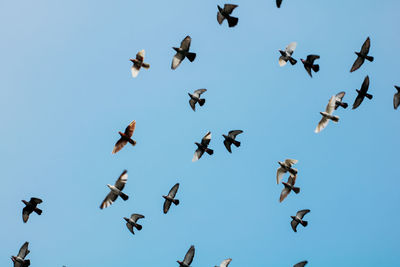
[11,0,400,267]
